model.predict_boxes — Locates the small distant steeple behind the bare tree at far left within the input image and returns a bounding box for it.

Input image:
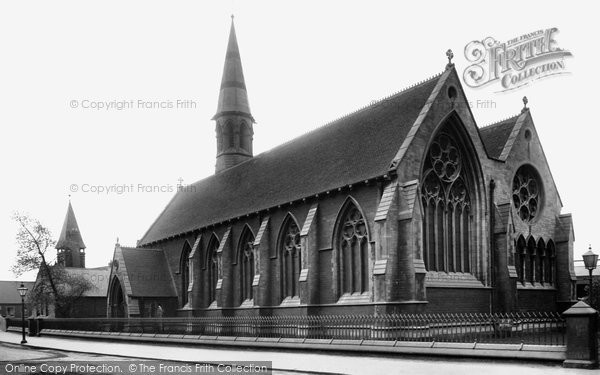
[56,200,85,268]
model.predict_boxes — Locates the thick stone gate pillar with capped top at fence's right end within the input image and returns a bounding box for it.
[563,301,598,369]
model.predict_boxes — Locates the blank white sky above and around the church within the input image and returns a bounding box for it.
[0,1,600,279]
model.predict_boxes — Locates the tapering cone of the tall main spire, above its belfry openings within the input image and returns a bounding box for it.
[213,15,254,121]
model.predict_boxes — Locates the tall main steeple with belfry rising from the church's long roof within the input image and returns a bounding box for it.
[213,16,254,172]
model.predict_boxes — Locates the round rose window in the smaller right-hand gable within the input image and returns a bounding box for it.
[513,165,542,222]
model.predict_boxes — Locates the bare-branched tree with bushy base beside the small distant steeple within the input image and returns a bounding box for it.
[11,212,93,317]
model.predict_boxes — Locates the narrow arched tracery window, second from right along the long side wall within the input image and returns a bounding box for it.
[280,216,301,299]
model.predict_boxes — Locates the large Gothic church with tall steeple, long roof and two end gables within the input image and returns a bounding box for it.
[107,21,576,317]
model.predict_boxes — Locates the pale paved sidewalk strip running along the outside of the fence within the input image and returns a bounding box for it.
[0,332,596,375]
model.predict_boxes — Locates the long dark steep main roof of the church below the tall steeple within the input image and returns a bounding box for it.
[140,72,439,246]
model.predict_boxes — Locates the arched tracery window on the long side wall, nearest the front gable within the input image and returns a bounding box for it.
[338,203,369,294]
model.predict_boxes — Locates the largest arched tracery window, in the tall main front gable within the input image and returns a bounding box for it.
[421,133,471,272]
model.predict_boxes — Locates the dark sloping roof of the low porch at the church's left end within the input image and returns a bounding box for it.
[121,247,177,297]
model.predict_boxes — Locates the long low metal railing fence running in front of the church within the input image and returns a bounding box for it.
[8,312,566,345]
